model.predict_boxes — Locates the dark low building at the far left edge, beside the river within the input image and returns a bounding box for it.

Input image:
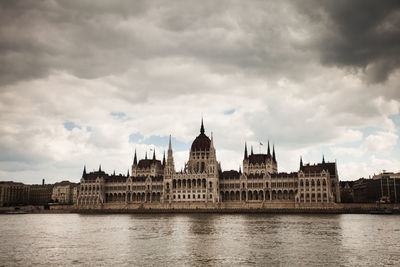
[0,181,29,206]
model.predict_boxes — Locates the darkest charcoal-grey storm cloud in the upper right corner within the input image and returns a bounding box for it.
[295,0,400,83]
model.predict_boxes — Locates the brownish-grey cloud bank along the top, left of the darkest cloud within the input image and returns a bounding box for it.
[0,1,314,87]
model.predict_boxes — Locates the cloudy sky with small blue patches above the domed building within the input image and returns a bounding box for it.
[0,0,400,184]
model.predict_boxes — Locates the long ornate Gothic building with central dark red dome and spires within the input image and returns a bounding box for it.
[77,122,340,208]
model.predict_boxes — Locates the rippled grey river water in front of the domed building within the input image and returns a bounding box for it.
[0,214,400,266]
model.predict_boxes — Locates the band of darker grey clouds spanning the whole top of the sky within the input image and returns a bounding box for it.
[0,1,400,88]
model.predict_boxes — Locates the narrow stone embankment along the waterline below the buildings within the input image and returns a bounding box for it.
[0,203,400,214]
